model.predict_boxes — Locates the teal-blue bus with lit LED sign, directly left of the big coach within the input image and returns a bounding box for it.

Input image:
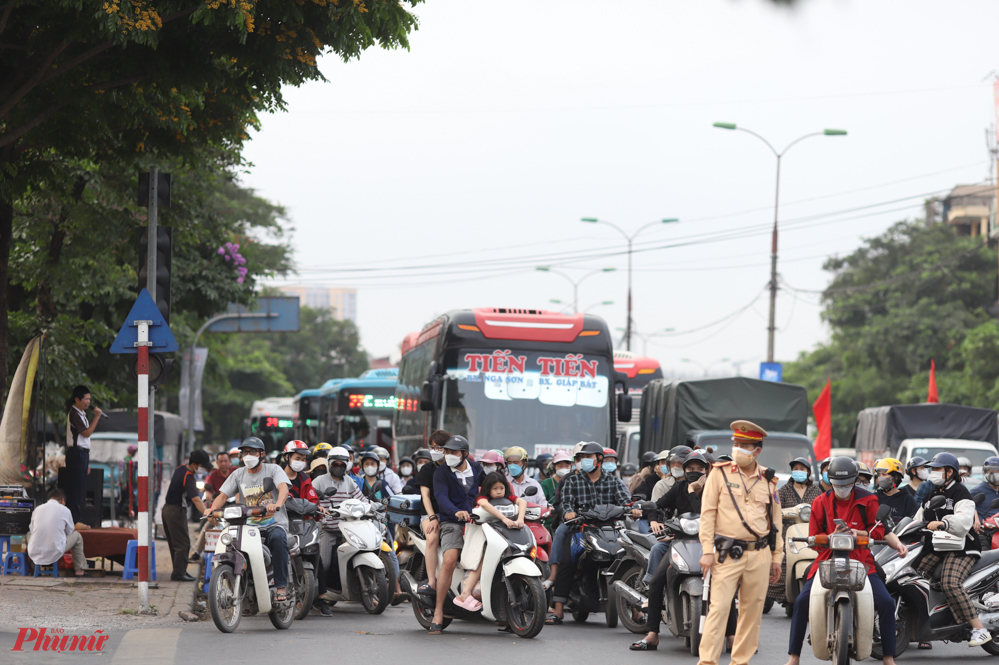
[319,368,398,461]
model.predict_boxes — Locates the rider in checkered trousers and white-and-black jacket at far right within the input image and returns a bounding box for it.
[916,453,992,647]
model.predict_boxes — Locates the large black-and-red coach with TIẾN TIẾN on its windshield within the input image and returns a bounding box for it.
[393,308,631,458]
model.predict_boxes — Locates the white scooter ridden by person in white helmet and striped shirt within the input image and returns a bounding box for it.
[324,499,391,614]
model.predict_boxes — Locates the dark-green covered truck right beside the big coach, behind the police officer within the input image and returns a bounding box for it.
[640,377,815,477]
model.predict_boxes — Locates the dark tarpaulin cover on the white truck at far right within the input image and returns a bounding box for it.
[853,404,999,453]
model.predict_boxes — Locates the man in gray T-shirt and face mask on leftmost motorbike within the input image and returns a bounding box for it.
[205,436,290,603]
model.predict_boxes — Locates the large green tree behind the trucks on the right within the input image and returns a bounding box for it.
[785,221,999,445]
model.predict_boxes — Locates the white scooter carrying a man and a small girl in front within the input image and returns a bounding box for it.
[400,499,548,638]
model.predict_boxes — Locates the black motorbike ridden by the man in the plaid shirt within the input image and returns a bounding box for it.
[565,505,625,628]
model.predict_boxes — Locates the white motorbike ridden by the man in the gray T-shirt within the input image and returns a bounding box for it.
[208,478,295,633]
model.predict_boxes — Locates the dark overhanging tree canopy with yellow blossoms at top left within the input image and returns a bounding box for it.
[0,0,419,400]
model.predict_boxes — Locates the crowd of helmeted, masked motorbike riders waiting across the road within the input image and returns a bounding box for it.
[197,430,999,665]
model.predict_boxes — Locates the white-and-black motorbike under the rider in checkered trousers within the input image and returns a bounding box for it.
[879,494,999,656]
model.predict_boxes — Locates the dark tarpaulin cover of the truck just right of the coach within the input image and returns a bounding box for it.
[641,377,809,452]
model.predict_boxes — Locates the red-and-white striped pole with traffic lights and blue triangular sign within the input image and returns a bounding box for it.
[138,166,159,612]
